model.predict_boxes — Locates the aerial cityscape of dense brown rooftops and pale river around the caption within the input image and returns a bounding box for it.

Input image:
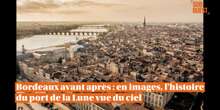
[16,0,203,110]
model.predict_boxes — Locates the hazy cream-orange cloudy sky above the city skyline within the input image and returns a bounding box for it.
[17,0,203,22]
